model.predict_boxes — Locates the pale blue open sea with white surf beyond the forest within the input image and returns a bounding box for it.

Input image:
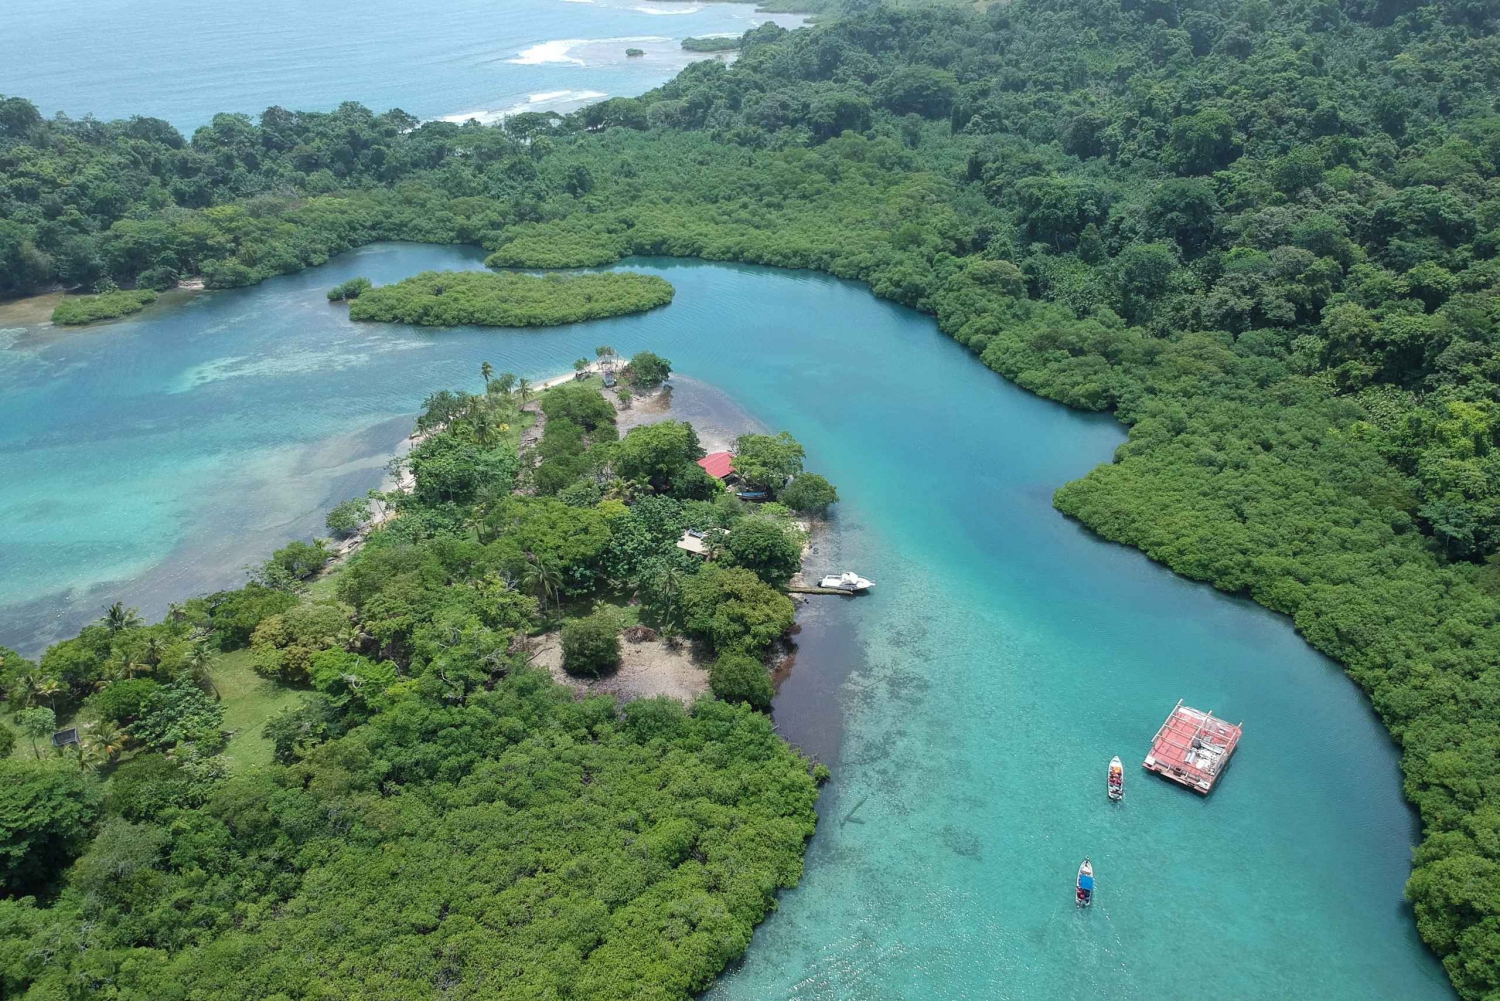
[0,0,803,132]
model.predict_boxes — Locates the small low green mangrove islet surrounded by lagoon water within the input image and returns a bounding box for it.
[340,272,674,327]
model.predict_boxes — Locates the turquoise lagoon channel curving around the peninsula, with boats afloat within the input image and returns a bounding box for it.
[0,246,1452,1001]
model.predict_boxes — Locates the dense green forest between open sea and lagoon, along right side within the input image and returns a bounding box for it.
[0,0,1500,998]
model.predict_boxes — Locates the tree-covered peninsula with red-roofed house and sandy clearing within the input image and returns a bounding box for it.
[0,347,837,1001]
